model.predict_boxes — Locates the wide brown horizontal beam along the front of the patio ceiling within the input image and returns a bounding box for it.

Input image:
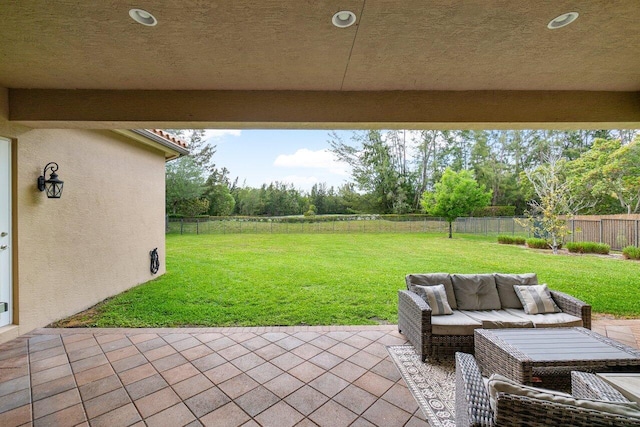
[8,89,640,129]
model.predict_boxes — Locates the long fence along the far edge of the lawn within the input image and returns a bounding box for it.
[166,215,640,250]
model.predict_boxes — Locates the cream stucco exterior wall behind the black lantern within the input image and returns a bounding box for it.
[5,130,165,341]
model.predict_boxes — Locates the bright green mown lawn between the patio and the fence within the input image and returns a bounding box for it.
[59,233,640,327]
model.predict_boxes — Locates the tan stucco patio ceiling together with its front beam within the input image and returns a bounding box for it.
[0,0,640,128]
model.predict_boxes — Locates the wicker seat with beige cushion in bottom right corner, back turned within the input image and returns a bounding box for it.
[455,353,640,427]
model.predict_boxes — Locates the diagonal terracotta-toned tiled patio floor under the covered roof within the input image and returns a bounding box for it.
[0,320,640,427]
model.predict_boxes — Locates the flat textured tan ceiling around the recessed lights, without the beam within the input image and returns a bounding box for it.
[0,0,640,129]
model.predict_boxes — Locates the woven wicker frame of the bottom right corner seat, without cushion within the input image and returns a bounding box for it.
[456,353,640,427]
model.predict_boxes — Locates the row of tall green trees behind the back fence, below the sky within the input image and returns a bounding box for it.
[166,129,640,216]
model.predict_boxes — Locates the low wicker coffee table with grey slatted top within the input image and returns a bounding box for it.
[474,328,640,391]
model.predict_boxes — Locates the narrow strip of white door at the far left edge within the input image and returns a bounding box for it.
[0,138,13,327]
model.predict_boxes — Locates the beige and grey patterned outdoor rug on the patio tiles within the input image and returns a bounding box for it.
[387,345,456,427]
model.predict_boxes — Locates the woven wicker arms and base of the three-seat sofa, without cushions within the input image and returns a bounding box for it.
[398,276,591,361]
